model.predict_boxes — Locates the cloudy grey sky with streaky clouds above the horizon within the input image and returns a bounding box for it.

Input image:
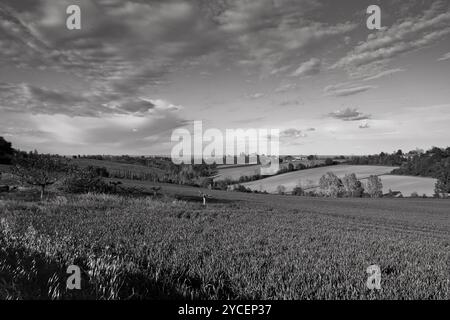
[0,0,450,155]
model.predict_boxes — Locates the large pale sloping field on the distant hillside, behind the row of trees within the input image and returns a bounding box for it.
[242,165,396,193]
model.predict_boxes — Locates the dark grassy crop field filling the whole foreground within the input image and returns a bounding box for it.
[0,188,450,299]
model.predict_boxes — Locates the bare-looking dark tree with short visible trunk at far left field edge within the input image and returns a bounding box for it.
[13,153,69,199]
